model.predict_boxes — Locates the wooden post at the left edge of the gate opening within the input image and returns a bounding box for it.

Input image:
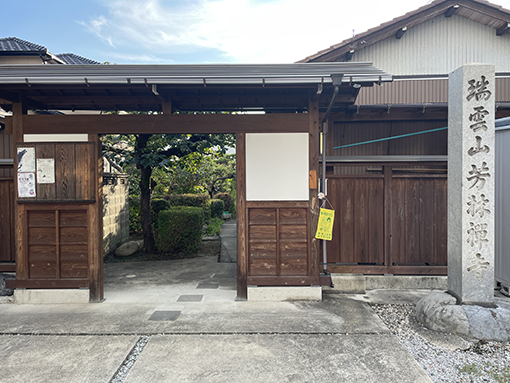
[89,134,104,302]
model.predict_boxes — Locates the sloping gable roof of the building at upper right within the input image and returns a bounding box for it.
[299,0,510,62]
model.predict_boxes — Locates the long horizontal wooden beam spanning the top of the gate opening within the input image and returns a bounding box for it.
[13,113,308,134]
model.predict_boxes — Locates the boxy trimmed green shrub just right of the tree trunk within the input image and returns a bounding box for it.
[156,206,204,254]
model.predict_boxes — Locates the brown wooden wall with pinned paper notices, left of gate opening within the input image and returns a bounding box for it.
[15,141,103,294]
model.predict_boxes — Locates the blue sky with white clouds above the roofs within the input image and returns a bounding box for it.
[0,0,510,64]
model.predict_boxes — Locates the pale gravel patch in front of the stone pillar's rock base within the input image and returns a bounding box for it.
[372,304,510,383]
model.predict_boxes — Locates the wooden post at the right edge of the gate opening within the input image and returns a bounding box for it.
[236,133,248,300]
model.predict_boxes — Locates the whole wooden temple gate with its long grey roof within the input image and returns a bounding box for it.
[0,63,391,302]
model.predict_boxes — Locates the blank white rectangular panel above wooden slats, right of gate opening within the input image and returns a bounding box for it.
[246,133,309,201]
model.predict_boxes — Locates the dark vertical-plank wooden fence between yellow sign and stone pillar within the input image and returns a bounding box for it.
[327,167,447,274]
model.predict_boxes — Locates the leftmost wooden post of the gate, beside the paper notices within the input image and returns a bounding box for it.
[12,102,28,280]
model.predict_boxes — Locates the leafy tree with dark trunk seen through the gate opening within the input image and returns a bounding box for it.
[102,127,235,252]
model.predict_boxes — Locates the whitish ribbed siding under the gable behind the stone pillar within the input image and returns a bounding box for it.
[353,16,510,75]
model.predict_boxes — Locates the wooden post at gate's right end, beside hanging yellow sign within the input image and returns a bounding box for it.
[308,97,324,284]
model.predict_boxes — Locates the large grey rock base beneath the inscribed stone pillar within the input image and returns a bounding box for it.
[416,292,510,342]
